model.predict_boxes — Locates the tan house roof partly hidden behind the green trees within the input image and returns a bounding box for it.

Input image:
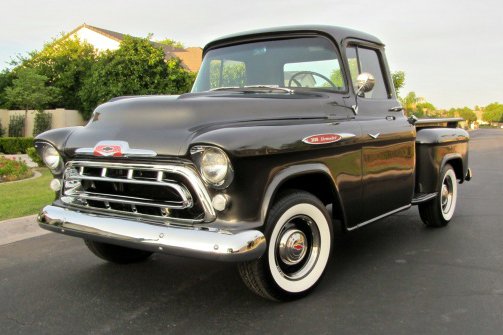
[66,23,203,72]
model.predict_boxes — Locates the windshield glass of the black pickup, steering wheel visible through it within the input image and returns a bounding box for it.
[192,37,346,92]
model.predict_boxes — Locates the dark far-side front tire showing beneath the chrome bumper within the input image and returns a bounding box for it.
[84,240,152,264]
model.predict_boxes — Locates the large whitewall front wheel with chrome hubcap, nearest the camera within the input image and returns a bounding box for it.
[239,191,332,300]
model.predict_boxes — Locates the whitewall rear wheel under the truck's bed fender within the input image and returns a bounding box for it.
[419,164,458,227]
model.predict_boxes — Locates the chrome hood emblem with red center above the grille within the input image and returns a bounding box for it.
[75,141,157,157]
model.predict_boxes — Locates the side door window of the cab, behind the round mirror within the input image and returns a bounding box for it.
[346,46,390,99]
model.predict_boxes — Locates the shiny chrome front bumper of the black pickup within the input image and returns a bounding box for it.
[38,206,266,262]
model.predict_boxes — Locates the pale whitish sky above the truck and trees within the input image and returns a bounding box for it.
[0,0,503,108]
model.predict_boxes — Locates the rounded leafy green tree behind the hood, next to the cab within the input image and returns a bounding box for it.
[79,37,194,119]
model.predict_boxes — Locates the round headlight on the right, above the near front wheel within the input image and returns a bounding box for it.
[190,146,233,188]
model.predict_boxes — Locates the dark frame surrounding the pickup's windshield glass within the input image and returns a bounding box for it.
[191,31,350,94]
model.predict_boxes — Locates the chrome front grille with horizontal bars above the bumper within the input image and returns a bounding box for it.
[61,161,215,223]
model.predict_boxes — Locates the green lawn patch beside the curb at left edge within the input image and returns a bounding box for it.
[0,168,54,221]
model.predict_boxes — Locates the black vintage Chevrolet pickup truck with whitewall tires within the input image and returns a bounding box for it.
[35,26,472,301]
